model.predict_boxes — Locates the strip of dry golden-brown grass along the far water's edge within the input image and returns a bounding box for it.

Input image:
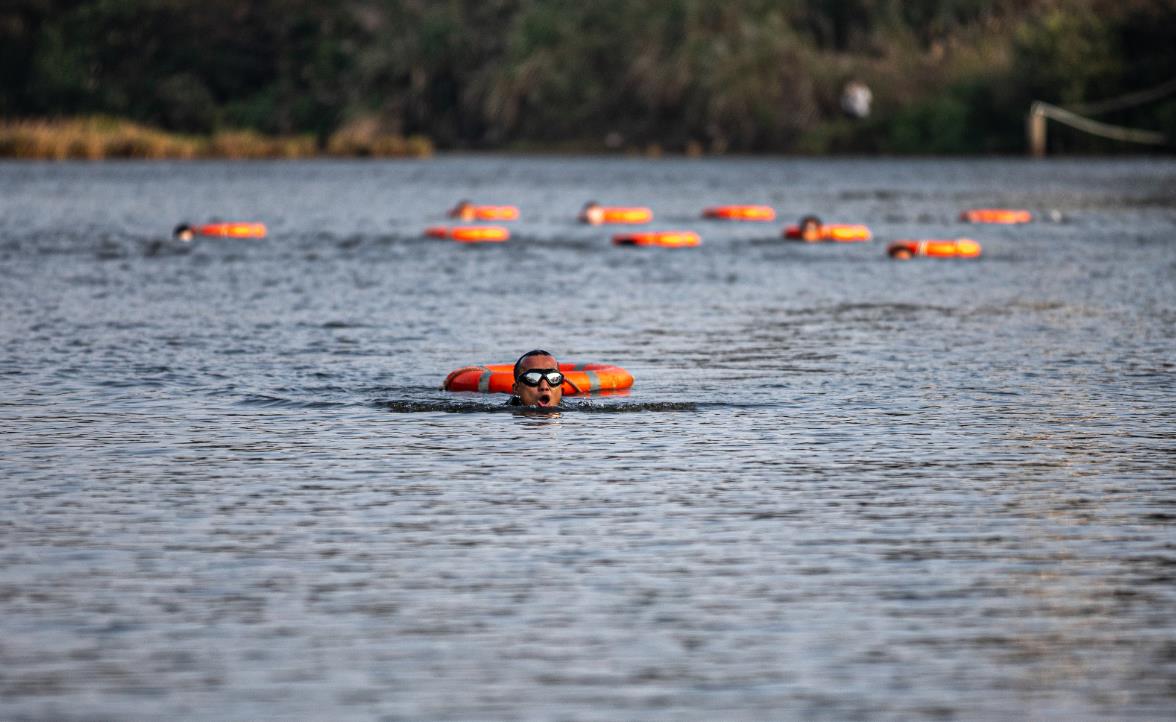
[0,116,433,160]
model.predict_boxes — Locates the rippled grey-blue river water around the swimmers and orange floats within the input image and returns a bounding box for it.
[0,156,1176,720]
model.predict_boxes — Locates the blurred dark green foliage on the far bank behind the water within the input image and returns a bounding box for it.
[0,0,1176,154]
